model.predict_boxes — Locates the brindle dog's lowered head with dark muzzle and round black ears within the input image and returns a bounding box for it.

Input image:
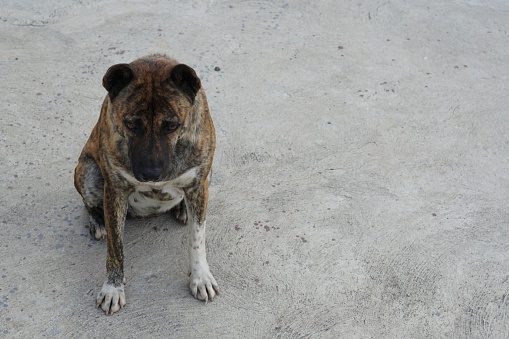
[103,57,201,182]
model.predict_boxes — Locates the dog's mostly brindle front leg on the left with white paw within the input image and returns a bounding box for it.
[97,181,128,314]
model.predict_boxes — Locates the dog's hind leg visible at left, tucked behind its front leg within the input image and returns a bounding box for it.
[74,153,106,240]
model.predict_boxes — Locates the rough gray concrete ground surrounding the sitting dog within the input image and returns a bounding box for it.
[0,0,509,338]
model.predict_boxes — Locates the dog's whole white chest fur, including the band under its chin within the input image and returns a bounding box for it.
[122,167,198,217]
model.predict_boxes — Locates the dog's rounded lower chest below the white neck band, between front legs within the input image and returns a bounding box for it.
[128,185,184,217]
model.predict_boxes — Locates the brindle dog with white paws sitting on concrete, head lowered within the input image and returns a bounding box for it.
[74,54,219,314]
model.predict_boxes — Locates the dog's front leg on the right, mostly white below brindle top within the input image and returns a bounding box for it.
[185,179,219,302]
